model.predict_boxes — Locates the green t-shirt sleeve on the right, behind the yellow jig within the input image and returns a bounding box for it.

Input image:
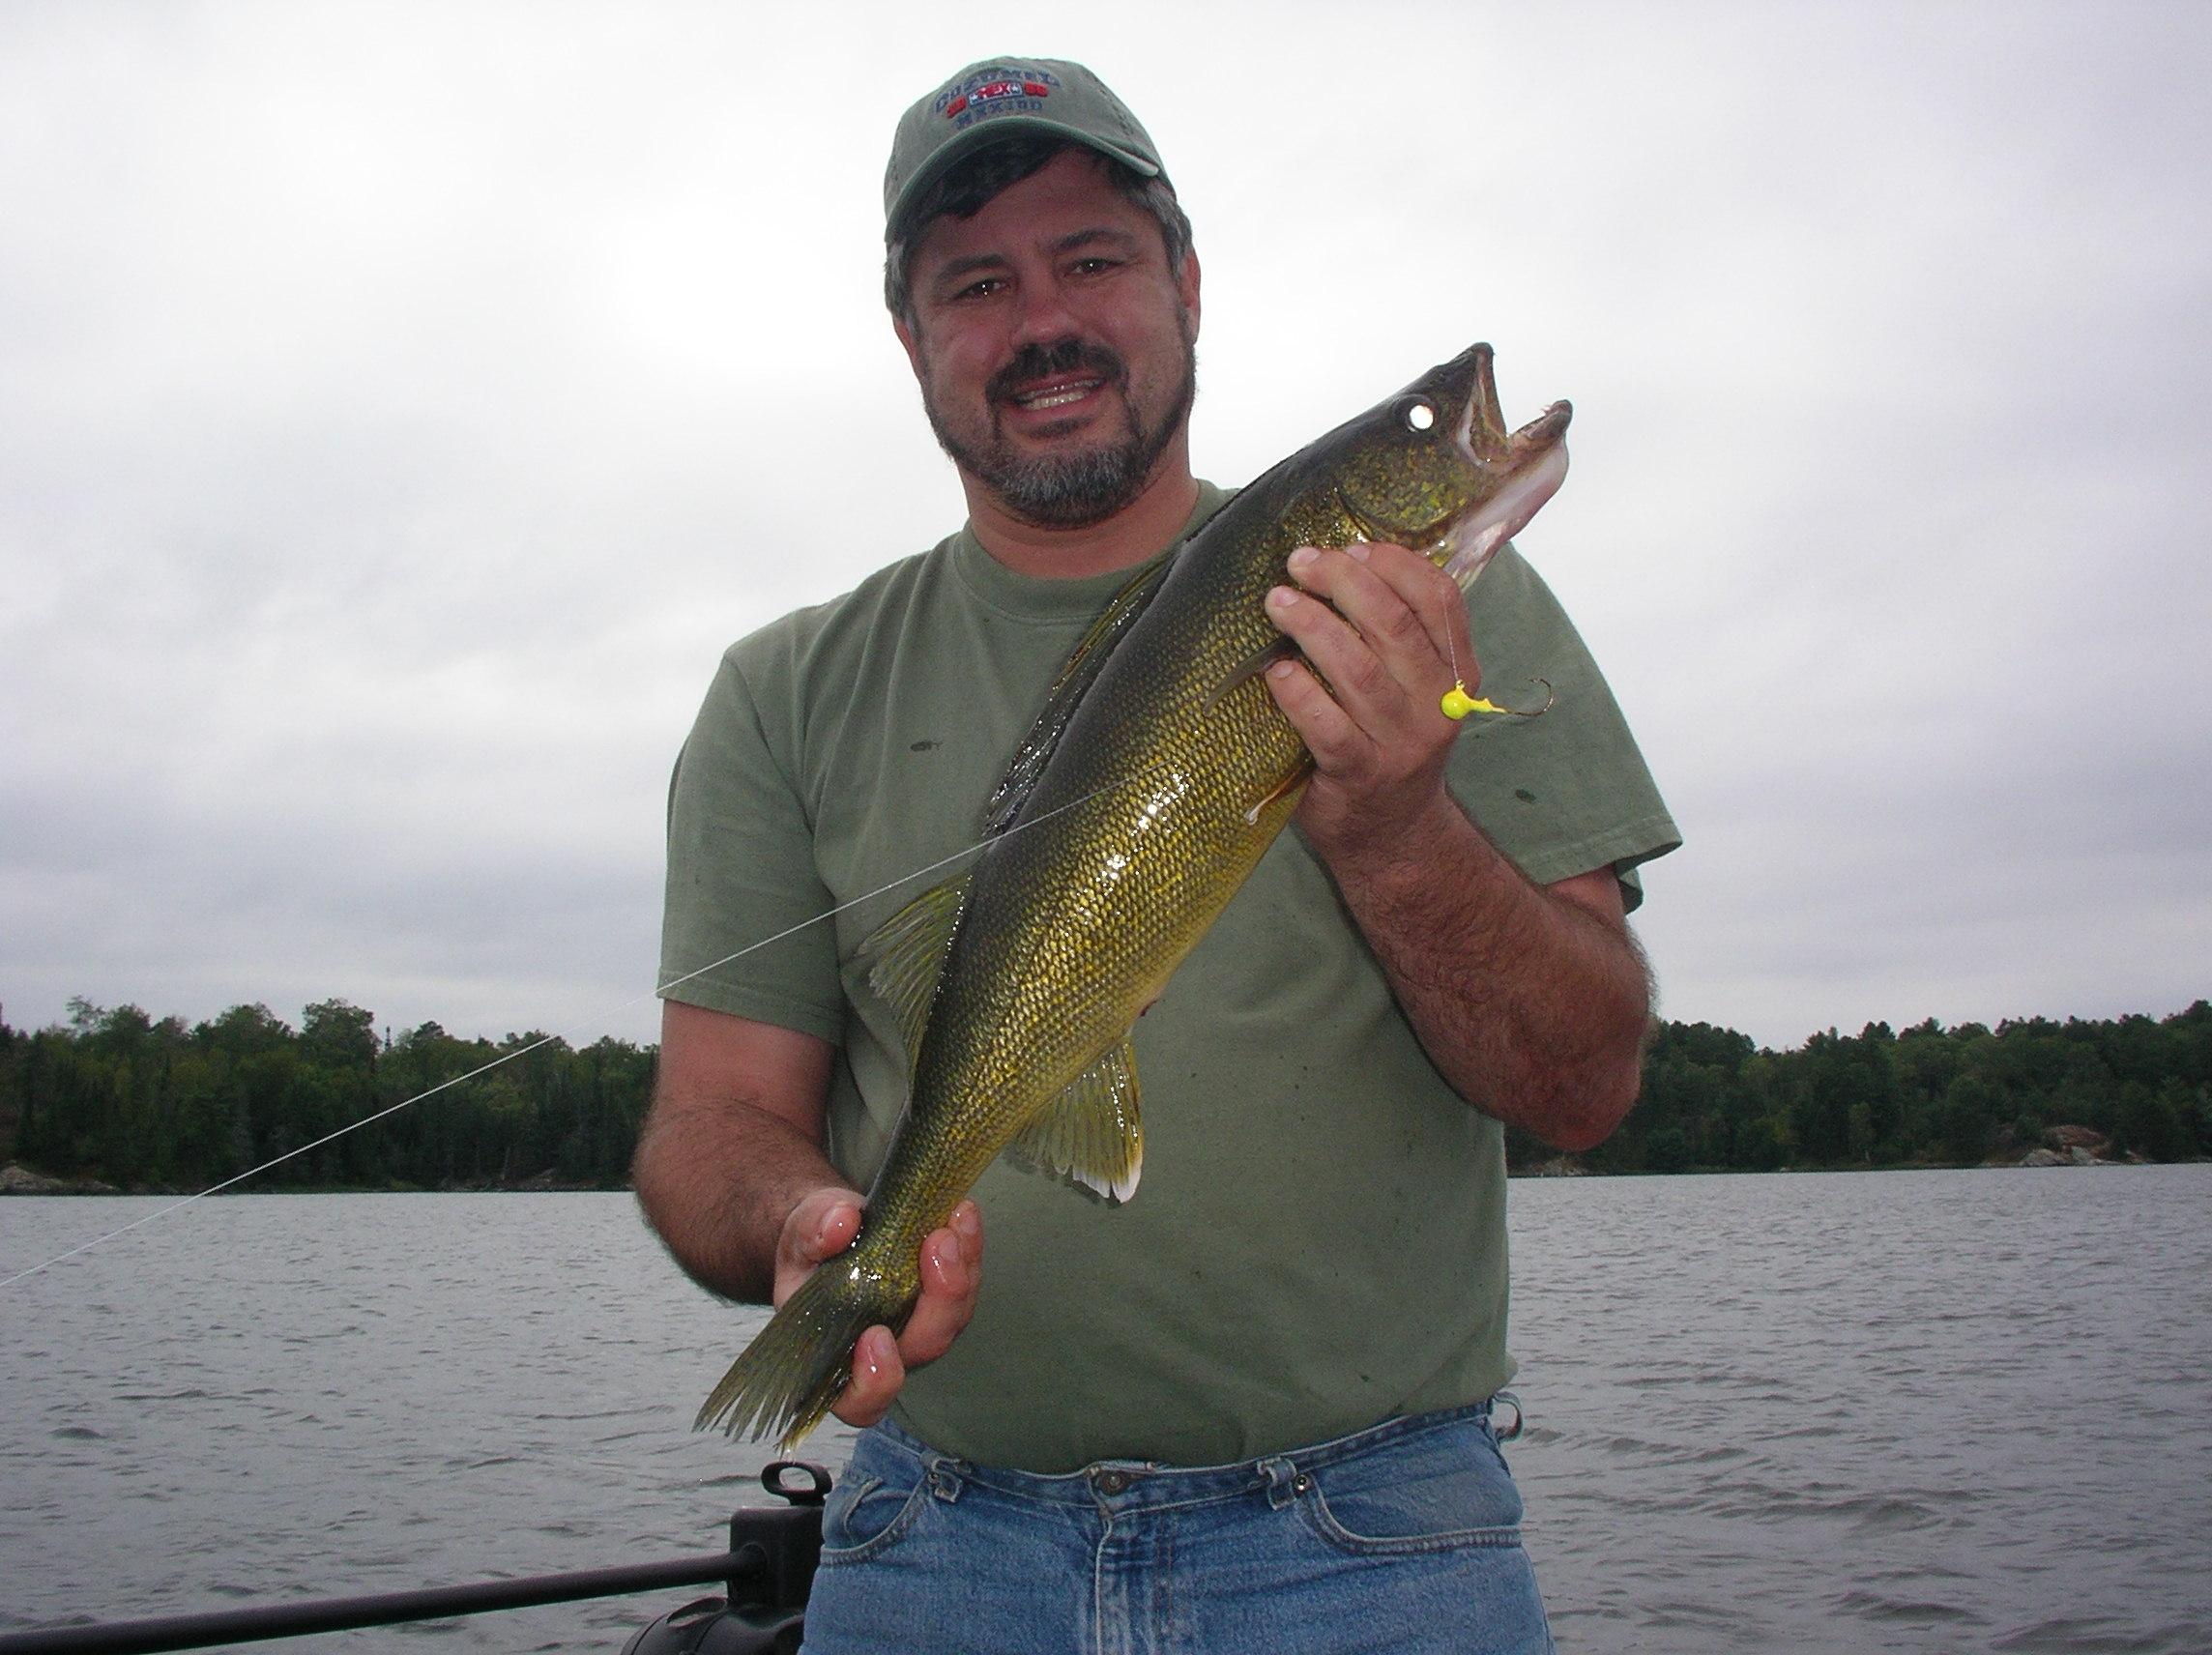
[1451,544,1681,910]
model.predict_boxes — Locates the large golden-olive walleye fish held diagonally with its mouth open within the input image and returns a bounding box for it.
[699,345,1570,1447]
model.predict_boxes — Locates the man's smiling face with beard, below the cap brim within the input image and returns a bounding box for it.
[898,148,1199,529]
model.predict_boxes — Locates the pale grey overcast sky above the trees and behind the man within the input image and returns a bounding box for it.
[0,0,2212,1061]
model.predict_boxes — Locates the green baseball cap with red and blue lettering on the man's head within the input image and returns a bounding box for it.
[883,58,1168,239]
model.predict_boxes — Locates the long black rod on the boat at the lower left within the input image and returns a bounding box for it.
[0,1547,759,1655]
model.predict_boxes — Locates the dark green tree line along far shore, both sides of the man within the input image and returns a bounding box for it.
[0,1001,2212,1190]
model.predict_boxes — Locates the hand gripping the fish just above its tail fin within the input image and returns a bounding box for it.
[776,1188,982,1427]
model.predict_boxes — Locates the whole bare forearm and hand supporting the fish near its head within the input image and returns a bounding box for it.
[1267,544,1650,1150]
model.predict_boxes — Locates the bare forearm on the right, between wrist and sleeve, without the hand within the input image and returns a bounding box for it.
[1309,792,1650,1150]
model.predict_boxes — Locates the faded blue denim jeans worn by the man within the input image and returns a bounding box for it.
[805,1405,1553,1655]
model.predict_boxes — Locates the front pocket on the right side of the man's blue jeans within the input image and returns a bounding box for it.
[1298,1420,1522,1555]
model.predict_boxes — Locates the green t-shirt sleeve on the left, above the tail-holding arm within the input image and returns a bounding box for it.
[659,644,845,1040]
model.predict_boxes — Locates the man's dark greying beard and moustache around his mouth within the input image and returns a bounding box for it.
[922,323,1199,529]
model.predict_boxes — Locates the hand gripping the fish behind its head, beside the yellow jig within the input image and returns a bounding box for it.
[1267,544,1480,863]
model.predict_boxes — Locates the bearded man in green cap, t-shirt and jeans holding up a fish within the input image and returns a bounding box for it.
[637,60,1676,1650]
